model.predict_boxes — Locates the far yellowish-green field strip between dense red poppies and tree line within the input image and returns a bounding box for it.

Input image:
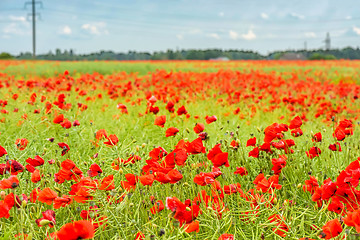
[0,60,360,81]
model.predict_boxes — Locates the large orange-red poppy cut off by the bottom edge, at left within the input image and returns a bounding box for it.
[56,220,95,240]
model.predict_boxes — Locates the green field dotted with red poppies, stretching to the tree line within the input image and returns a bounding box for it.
[0,60,360,240]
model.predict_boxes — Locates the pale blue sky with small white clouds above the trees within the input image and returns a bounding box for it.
[0,0,360,54]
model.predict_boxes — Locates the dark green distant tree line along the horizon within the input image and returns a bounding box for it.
[0,47,360,61]
